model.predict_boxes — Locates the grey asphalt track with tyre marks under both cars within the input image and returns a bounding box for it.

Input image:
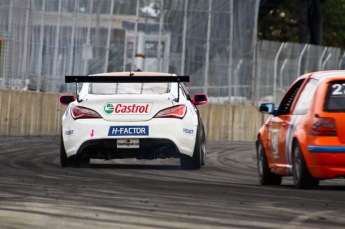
[0,138,345,229]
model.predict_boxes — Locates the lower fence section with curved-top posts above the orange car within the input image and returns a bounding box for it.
[253,41,344,104]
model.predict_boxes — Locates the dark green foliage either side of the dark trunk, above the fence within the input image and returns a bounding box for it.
[258,0,345,48]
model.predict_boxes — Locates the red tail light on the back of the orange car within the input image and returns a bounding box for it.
[309,117,337,136]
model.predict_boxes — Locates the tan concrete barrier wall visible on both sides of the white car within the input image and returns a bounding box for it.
[0,89,263,141]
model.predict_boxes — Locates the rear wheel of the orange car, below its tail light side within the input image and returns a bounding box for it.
[292,142,319,189]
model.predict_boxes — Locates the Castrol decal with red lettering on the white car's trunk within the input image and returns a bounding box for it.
[103,103,152,115]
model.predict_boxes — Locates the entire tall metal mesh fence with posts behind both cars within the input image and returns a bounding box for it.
[0,0,344,104]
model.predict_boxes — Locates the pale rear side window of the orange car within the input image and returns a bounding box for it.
[293,79,319,115]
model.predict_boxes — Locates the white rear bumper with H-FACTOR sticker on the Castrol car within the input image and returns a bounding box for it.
[62,119,197,158]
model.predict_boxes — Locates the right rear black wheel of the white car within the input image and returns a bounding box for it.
[180,131,206,169]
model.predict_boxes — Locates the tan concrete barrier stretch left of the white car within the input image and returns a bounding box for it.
[0,89,66,137]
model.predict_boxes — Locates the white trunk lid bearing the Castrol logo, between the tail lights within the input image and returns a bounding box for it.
[77,94,177,122]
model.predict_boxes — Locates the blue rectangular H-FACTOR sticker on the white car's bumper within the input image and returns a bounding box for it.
[108,126,149,136]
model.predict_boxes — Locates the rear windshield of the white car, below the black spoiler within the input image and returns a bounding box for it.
[89,83,171,95]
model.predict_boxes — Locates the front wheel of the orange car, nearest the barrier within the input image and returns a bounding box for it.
[257,139,282,185]
